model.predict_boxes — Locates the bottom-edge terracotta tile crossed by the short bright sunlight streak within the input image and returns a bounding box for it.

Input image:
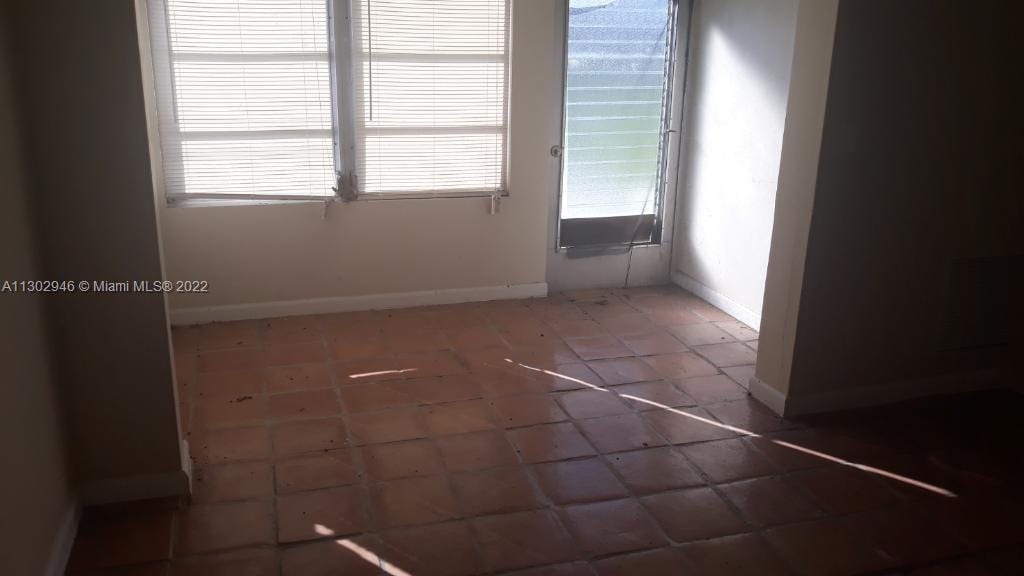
[280,536,383,576]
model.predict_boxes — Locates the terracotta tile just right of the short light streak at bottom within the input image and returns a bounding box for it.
[379,522,480,576]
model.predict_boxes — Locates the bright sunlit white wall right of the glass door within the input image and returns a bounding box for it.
[673,0,799,327]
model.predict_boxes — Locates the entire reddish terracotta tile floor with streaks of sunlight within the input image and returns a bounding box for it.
[71,288,1024,576]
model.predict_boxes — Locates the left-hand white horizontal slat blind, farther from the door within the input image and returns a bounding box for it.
[150,0,335,198]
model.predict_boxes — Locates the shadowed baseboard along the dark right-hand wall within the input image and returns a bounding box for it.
[751,371,1007,417]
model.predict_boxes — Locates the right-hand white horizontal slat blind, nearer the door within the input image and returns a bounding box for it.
[352,0,509,194]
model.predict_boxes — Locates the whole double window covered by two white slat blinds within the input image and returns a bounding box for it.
[150,0,509,201]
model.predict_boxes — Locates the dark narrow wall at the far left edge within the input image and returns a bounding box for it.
[0,12,73,576]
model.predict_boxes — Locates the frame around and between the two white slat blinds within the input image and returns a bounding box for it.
[146,0,512,206]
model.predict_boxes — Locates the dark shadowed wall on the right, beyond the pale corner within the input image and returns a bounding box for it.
[757,0,1024,414]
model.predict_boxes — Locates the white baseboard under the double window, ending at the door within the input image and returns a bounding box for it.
[171,282,548,326]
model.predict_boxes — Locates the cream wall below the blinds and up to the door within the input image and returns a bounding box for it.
[155,0,563,318]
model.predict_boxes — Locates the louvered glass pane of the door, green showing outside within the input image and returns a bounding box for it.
[559,0,677,247]
